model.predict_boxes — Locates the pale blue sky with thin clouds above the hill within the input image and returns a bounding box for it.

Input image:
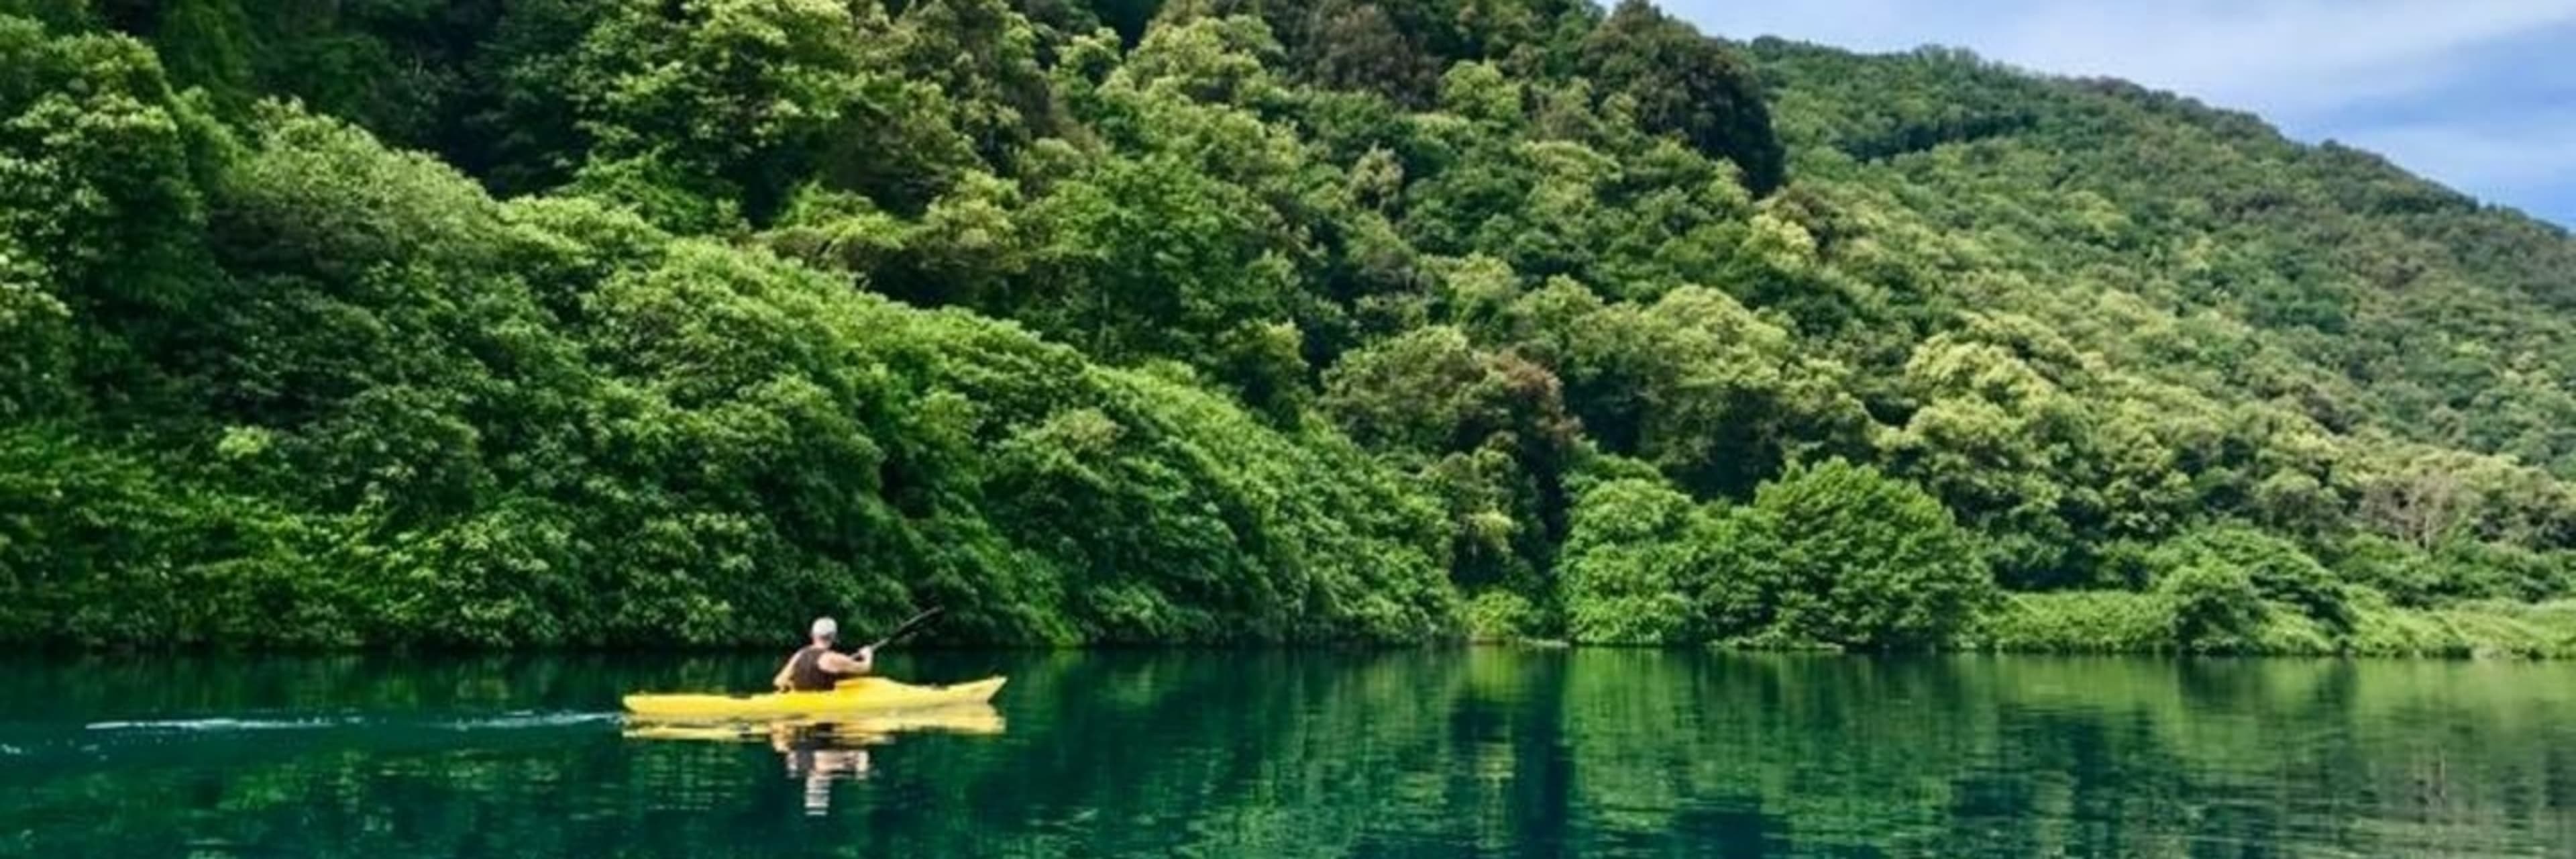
[1659,0,2576,227]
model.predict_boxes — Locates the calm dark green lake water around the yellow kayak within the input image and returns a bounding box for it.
[0,650,2576,856]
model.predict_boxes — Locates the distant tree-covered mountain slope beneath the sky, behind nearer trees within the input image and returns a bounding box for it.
[1754,39,2576,474]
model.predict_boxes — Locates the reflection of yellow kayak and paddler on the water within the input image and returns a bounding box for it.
[626,704,1002,815]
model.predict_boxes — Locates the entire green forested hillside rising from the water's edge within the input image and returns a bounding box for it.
[0,0,2576,655]
